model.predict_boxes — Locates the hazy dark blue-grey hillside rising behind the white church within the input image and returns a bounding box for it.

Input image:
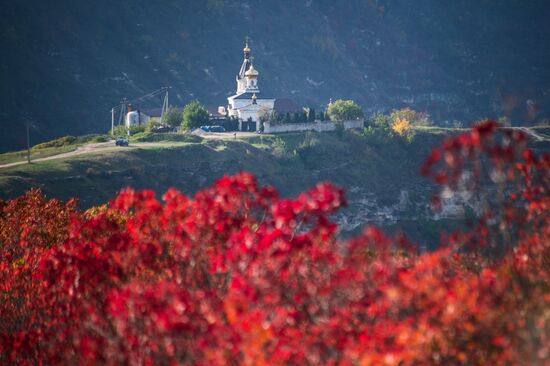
[0,0,550,151]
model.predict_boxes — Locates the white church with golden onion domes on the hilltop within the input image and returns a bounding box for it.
[227,41,275,131]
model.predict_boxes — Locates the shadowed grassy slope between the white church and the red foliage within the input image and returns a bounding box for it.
[0,129,550,245]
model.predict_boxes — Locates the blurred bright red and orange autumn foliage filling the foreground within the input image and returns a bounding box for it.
[0,122,550,365]
